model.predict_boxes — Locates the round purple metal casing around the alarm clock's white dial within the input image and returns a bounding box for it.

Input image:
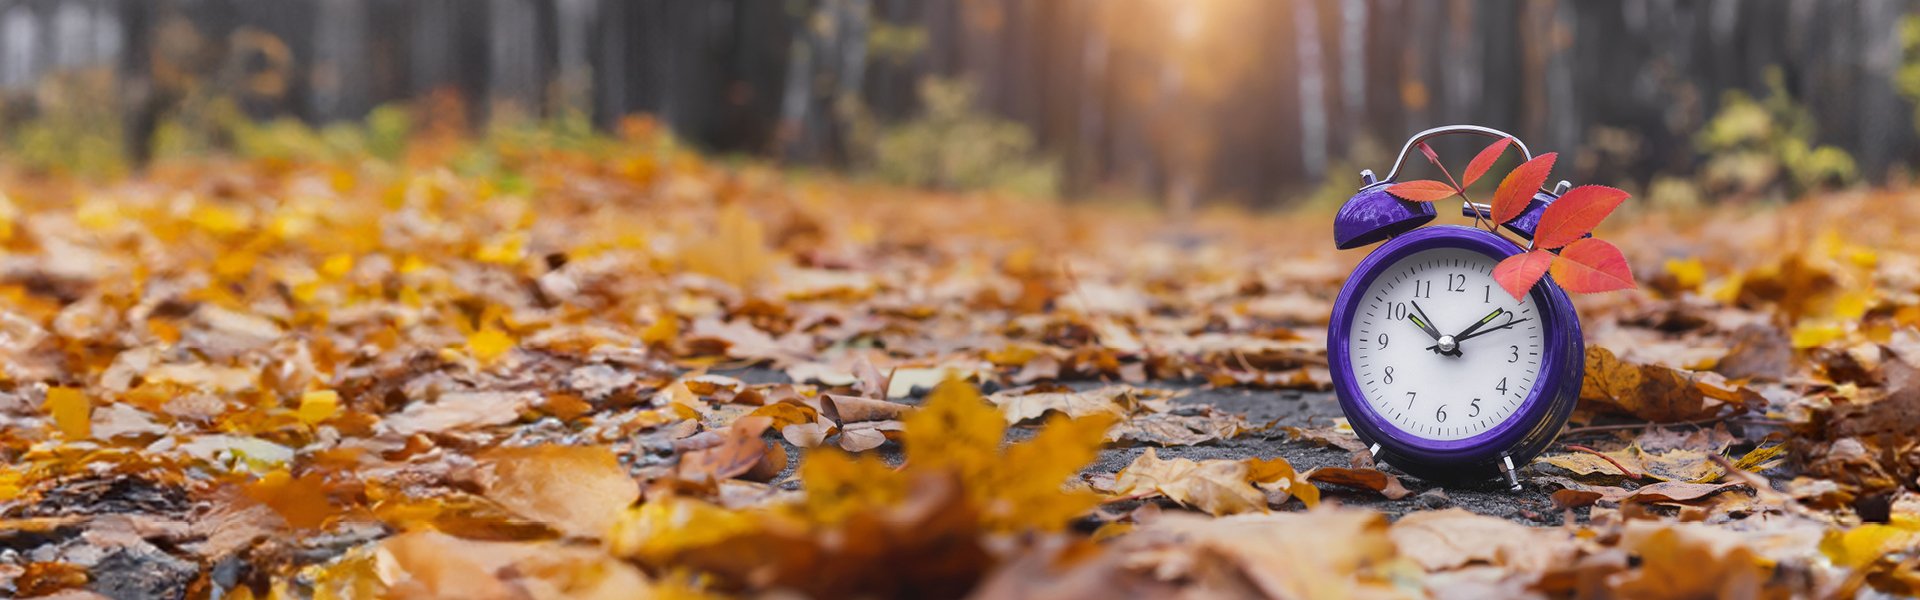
[1327,225,1586,479]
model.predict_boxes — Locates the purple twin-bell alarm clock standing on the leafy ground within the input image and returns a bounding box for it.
[1327,125,1586,490]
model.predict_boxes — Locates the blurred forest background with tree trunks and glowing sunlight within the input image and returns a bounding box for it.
[0,0,1920,208]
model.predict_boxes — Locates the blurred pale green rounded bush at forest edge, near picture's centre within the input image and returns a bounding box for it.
[866,79,1060,196]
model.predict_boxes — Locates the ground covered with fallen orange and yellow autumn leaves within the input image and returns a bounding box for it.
[0,127,1920,598]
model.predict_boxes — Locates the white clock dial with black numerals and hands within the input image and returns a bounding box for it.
[1348,248,1544,440]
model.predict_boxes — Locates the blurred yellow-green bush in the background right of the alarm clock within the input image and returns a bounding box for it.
[1693,67,1859,196]
